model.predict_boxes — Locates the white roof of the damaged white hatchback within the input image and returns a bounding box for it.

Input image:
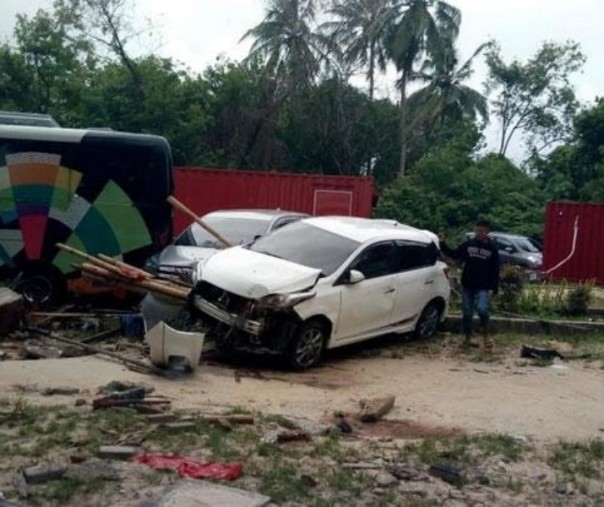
[304,216,434,243]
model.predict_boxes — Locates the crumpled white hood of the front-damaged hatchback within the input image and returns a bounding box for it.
[201,247,321,299]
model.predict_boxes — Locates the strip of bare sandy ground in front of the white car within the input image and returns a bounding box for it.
[0,346,604,440]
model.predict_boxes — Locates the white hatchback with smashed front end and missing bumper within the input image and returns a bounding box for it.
[193,217,450,369]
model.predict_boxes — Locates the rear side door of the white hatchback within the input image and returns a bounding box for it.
[392,242,439,327]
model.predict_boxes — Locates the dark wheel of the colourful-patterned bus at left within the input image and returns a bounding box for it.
[16,266,67,308]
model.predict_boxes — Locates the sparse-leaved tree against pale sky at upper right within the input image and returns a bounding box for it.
[487,41,585,160]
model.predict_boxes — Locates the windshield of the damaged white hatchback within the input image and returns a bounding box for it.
[248,222,360,276]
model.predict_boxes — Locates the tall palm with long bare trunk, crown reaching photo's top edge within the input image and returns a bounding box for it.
[389,0,461,175]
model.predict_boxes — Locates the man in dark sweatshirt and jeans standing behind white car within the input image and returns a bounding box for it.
[439,220,500,350]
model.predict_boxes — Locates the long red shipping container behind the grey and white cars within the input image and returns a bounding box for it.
[174,167,375,233]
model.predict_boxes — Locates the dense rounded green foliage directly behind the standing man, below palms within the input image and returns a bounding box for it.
[377,124,544,237]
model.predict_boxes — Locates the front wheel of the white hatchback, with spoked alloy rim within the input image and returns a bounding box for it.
[285,320,329,371]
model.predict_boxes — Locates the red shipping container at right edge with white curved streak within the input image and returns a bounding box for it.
[543,202,604,284]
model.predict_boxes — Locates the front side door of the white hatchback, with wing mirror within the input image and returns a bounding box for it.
[333,241,398,342]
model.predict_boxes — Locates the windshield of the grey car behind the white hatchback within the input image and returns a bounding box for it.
[175,216,270,248]
